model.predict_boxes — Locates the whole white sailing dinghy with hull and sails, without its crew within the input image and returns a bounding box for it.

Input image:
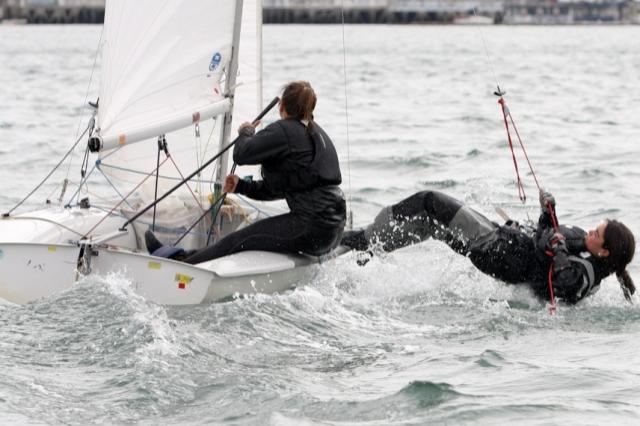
[0,0,344,305]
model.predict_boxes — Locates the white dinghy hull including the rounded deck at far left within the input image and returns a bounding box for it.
[0,199,340,305]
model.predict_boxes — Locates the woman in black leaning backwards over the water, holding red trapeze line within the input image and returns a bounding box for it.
[342,191,635,306]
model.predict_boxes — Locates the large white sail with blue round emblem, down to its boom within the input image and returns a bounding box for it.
[92,0,236,149]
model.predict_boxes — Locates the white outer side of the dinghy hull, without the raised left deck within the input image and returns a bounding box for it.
[0,243,336,305]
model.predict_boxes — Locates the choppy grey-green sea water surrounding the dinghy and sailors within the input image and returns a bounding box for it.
[0,25,640,425]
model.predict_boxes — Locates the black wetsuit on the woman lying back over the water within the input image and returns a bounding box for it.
[342,191,609,303]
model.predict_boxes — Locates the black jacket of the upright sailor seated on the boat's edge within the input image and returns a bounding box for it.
[233,118,346,228]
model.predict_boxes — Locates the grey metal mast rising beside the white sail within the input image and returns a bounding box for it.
[215,0,243,189]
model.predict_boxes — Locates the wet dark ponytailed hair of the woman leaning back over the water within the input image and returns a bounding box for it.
[602,220,636,301]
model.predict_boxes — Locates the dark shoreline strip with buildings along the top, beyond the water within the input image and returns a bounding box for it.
[0,0,640,25]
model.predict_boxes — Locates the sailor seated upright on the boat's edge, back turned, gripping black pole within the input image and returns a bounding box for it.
[145,81,346,264]
